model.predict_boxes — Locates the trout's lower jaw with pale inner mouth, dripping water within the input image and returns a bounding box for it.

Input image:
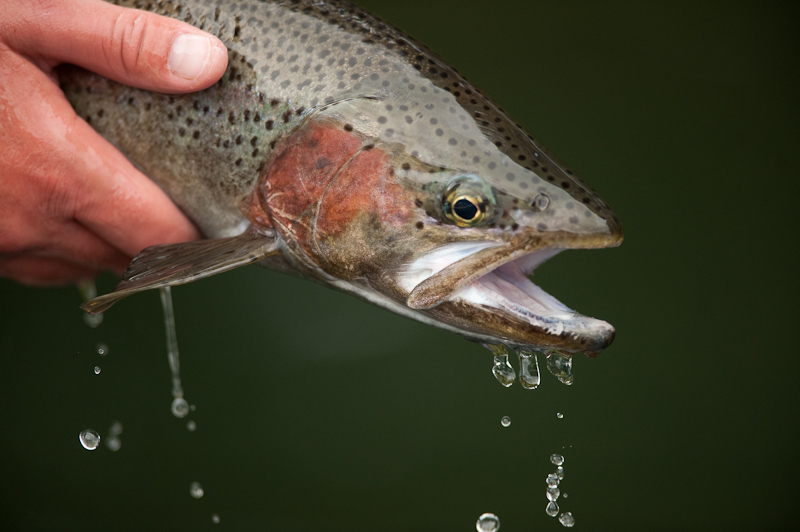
[452,250,614,354]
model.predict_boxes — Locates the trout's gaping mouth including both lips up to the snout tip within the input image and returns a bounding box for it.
[407,232,622,356]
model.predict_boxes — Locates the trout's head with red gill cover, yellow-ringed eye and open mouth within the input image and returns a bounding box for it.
[250,99,622,356]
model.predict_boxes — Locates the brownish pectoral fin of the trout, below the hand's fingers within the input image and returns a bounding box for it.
[81,228,279,314]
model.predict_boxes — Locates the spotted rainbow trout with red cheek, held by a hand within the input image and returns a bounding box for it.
[59,0,623,357]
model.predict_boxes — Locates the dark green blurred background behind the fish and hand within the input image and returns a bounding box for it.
[0,0,800,532]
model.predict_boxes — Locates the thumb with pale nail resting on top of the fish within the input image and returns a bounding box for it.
[4,0,228,93]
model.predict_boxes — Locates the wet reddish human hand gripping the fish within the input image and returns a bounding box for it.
[0,0,228,285]
